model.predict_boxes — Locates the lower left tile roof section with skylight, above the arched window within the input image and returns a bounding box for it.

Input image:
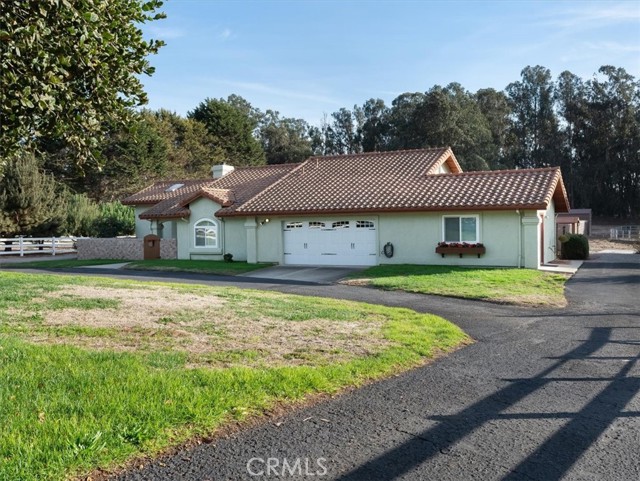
[122,164,297,219]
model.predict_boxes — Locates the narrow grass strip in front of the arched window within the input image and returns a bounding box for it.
[125,259,273,276]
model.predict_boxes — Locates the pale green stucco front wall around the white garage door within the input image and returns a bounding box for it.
[165,199,556,268]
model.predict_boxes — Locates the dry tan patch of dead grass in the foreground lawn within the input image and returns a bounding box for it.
[20,286,391,367]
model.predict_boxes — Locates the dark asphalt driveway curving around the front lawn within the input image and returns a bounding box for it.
[62,254,640,481]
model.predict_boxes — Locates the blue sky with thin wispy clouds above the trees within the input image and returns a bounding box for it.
[142,0,640,124]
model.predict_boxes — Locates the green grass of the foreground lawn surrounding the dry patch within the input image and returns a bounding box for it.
[0,272,469,480]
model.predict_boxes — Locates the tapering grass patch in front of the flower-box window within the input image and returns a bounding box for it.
[348,265,567,307]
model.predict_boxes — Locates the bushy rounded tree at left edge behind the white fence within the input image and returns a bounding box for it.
[0,154,67,237]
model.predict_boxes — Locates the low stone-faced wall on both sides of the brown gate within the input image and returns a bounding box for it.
[76,238,178,261]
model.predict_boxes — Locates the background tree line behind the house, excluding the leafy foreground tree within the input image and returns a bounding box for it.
[55,66,640,218]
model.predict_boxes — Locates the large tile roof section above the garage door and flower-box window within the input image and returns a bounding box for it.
[226,160,568,215]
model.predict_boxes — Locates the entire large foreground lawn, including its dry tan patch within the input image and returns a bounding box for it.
[0,271,469,480]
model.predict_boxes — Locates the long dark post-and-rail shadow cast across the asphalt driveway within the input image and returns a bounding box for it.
[339,327,640,481]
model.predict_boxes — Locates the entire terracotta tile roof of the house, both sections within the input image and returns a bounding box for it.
[123,148,569,219]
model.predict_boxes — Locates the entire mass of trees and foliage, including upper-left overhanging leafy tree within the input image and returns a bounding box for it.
[0,0,640,236]
